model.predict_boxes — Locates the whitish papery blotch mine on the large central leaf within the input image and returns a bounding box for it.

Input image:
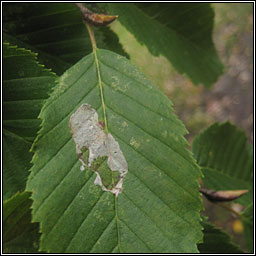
[69,104,128,196]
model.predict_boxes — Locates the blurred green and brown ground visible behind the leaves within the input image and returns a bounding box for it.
[111,3,253,250]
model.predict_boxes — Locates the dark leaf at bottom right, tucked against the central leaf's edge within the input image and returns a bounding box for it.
[198,221,244,254]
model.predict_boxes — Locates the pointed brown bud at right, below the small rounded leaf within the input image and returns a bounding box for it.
[199,188,248,202]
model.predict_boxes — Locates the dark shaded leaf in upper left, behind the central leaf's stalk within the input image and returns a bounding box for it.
[3,3,127,75]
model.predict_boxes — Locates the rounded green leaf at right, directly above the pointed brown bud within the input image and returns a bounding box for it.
[192,122,253,205]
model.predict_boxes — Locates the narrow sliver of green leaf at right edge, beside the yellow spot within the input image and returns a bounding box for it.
[241,203,254,253]
